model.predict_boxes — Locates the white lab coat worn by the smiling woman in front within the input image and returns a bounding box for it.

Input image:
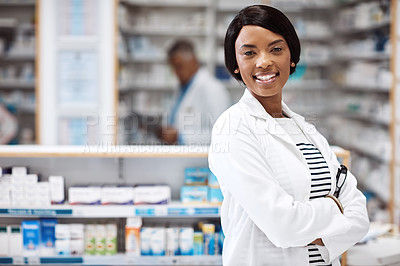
[209,90,369,266]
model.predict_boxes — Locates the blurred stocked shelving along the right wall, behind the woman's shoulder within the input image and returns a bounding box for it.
[329,0,400,223]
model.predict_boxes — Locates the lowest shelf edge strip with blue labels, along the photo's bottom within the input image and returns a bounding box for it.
[0,254,222,266]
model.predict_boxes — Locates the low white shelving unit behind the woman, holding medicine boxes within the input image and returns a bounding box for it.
[0,145,350,266]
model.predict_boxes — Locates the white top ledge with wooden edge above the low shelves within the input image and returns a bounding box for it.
[0,145,209,158]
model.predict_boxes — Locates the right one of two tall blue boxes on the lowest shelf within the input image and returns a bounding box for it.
[40,219,58,256]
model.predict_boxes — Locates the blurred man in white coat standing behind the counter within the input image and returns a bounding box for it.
[160,40,231,145]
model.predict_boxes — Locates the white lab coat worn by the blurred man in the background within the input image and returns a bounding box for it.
[173,68,231,145]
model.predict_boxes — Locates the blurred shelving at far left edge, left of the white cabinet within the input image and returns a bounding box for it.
[0,0,36,144]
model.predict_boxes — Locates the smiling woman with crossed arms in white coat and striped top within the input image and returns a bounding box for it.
[209,5,369,266]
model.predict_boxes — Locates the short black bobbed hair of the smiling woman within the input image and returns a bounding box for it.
[224,5,301,82]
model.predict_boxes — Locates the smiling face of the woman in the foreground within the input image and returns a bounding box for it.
[235,25,290,98]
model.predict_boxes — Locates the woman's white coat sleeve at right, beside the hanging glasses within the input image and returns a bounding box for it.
[321,139,369,261]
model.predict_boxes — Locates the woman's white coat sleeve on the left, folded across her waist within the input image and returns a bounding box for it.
[209,109,351,248]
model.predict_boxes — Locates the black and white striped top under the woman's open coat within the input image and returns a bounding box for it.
[276,118,332,266]
